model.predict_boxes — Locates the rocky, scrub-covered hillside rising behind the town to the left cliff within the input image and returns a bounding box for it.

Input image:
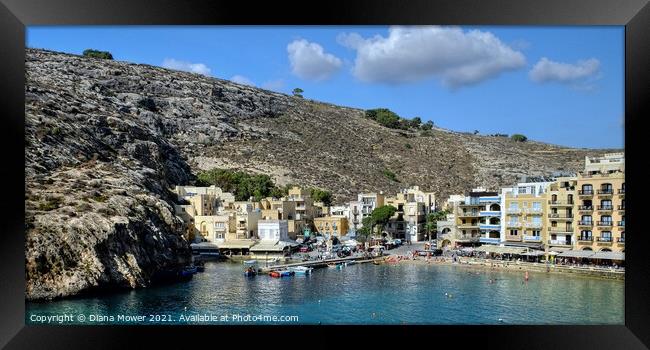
[25,49,603,299]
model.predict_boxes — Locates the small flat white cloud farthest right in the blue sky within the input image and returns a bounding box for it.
[528,57,600,84]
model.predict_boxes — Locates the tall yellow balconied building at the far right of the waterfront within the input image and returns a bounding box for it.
[575,153,625,252]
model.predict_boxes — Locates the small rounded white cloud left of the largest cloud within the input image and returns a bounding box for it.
[287,39,343,81]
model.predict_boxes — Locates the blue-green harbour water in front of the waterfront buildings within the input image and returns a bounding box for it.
[25,262,624,325]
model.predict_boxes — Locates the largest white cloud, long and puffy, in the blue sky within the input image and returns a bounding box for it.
[337,26,526,88]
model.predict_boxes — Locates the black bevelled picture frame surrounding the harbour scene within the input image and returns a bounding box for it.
[0,0,650,349]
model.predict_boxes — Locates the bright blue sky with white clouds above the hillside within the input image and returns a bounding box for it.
[27,26,625,148]
